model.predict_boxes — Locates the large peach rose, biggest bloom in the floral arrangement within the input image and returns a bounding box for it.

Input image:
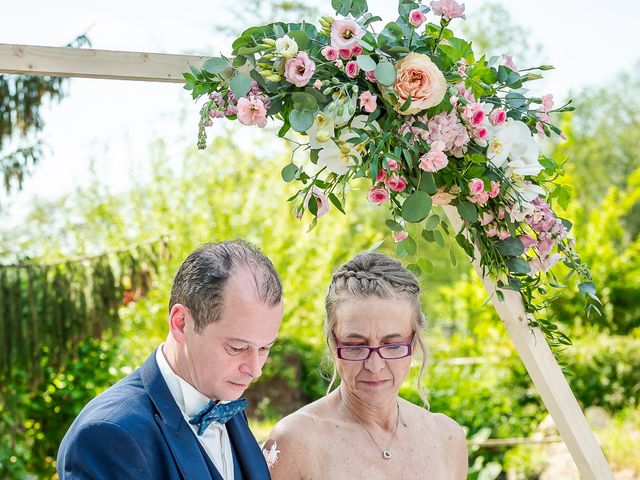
[393,52,447,115]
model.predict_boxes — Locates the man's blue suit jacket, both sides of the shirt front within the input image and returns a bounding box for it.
[56,352,270,480]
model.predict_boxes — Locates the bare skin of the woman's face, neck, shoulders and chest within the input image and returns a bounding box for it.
[262,297,467,480]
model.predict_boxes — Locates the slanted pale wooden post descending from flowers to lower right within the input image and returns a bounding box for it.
[443,205,614,480]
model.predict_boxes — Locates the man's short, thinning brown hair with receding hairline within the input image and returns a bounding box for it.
[169,239,282,333]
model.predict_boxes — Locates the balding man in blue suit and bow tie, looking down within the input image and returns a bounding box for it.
[57,240,282,480]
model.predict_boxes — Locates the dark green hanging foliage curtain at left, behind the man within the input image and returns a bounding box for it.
[0,238,168,388]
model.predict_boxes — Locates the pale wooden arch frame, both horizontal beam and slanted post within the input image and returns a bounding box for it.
[0,44,613,480]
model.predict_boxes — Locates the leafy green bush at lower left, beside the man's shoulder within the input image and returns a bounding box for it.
[0,338,121,479]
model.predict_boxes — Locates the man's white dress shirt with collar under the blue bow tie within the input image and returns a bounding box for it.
[156,343,233,480]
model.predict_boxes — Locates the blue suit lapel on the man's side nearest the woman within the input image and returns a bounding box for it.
[226,412,271,480]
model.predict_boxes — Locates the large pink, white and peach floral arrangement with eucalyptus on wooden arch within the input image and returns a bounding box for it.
[184,0,600,345]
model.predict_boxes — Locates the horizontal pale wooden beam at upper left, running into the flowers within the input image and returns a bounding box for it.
[0,43,207,83]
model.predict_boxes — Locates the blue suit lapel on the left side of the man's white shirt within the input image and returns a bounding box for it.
[140,351,223,480]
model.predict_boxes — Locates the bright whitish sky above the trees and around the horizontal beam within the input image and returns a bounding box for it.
[0,0,640,223]
